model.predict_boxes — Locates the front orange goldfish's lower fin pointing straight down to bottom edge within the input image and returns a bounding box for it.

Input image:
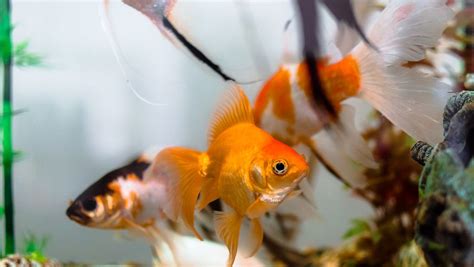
[214,211,243,266]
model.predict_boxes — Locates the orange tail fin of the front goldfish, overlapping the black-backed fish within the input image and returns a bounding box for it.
[145,147,207,240]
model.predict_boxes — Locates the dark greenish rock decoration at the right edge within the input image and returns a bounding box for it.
[412,91,474,266]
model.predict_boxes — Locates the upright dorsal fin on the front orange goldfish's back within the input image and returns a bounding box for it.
[209,86,254,143]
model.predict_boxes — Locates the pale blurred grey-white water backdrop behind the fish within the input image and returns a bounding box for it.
[5,0,372,264]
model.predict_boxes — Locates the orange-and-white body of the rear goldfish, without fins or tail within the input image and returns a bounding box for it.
[254,55,361,146]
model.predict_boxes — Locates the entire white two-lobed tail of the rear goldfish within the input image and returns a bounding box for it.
[351,0,453,144]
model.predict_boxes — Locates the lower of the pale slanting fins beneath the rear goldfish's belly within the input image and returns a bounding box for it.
[312,126,368,188]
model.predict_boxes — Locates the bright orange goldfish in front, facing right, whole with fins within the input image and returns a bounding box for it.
[145,87,309,265]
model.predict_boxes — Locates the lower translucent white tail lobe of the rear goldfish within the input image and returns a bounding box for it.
[353,45,450,145]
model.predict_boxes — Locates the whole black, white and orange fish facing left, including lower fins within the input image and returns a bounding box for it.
[66,155,183,264]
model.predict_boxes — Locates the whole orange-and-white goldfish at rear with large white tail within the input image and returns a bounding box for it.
[254,0,453,186]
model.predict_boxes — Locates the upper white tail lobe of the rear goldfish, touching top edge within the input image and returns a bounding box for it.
[359,0,454,65]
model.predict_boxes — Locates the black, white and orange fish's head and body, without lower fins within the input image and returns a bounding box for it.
[66,159,157,229]
